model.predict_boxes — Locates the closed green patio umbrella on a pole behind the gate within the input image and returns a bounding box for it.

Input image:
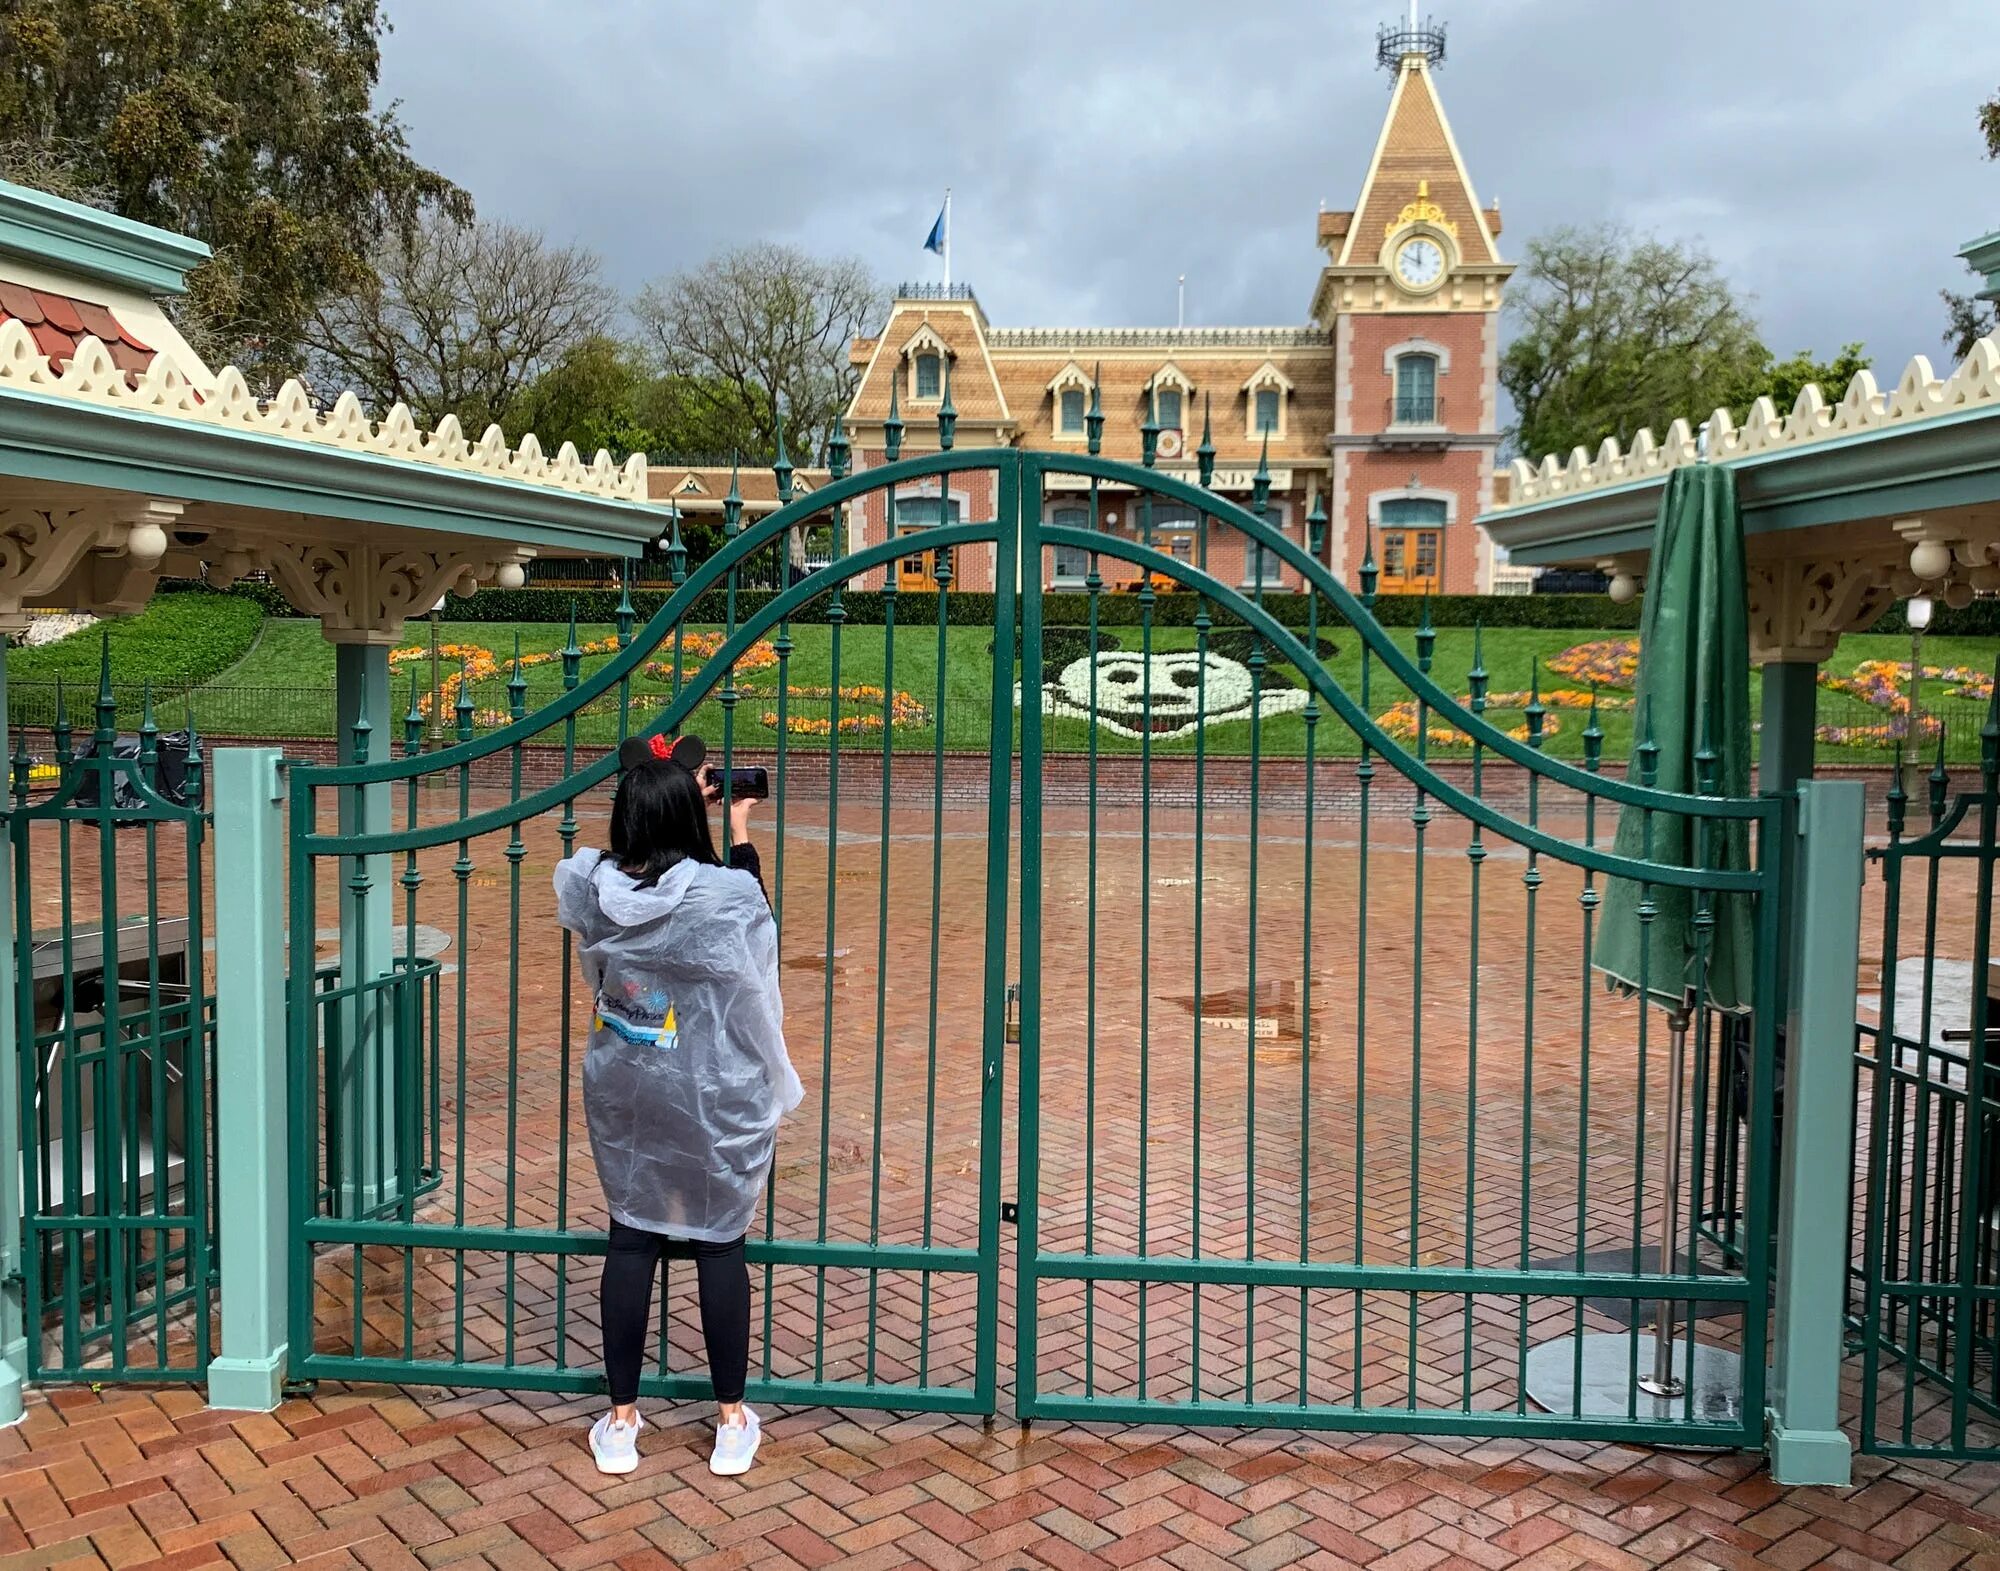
[1596,464,1756,1397]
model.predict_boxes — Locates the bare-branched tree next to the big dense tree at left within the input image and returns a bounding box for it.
[308,216,616,436]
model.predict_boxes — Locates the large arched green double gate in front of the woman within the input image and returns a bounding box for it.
[290,410,1778,1445]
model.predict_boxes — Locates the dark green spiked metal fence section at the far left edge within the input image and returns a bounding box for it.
[8,654,216,1381]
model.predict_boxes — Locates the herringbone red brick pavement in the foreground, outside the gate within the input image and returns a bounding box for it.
[0,1387,2000,1571]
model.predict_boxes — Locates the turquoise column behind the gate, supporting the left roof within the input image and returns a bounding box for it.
[326,644,398,1217]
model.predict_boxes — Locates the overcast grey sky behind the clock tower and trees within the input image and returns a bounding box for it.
[382,0,2000,376]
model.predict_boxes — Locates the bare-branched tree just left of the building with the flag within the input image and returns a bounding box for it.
[634,244,888,454]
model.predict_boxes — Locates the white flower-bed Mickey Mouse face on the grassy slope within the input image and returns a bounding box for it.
[1014,650,1308,740]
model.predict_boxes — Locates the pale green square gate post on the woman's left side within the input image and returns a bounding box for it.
[208,748,292,1411]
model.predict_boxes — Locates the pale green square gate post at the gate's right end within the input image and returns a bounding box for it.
[1766,782,1864,1485]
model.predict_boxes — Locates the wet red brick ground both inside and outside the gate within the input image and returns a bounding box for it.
[0,763,2000,1571]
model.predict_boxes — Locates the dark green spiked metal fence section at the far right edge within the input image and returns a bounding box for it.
[1850,694,2000,1457]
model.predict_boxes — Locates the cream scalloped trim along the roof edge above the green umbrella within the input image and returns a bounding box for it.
[1504,328,2000,512]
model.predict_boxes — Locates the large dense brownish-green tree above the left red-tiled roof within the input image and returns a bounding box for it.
[0,0,472,378]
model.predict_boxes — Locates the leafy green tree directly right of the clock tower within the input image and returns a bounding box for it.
[1500,226,1770,460]
